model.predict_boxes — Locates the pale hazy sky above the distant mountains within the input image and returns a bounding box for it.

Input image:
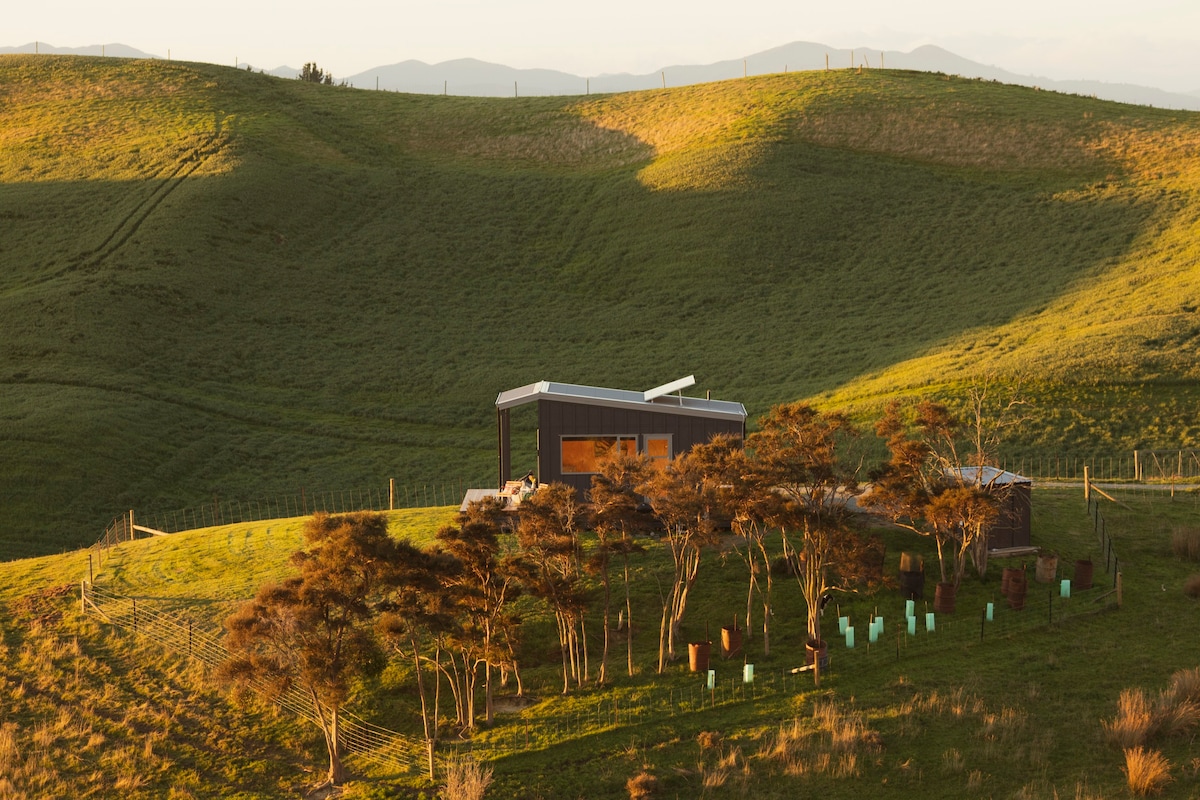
[9,0,1200,91]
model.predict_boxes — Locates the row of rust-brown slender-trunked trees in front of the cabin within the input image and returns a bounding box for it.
[224,403,1017,783]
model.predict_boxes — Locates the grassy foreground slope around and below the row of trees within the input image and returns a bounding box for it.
[0,488,1200,799]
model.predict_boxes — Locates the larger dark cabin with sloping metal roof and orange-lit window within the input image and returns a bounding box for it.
[496,375,746,497]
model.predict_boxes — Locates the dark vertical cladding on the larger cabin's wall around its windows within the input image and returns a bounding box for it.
[538,398,745,494]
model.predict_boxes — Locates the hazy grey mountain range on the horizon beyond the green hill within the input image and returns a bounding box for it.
[7,42,1200,110]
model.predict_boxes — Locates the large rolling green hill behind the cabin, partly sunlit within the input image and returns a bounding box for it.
[7,56,1200,557]
